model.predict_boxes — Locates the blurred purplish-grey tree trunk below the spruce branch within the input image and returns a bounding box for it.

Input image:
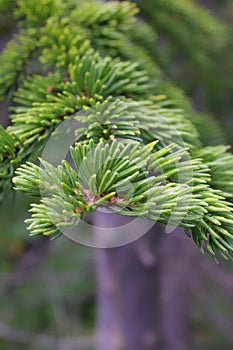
[95,214,197,350]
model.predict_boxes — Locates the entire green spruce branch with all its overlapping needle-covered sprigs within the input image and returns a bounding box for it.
[0,0,233,258]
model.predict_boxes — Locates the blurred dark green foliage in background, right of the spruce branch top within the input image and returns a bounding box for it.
[135,0,233,119]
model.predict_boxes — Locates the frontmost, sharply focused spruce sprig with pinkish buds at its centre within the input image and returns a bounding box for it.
[14,140,233,258]
